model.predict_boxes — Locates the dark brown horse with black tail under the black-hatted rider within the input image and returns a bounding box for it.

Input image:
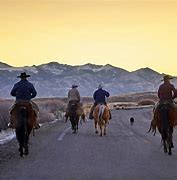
[11,101,36,157]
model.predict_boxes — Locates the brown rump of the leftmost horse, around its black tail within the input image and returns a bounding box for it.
[10,101,37,129]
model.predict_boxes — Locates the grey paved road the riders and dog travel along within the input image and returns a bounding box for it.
[0,108,177,180]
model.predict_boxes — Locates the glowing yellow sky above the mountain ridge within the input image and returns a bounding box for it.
[0,0,177,76]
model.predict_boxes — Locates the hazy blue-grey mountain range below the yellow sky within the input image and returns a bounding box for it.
[0,62,177,98]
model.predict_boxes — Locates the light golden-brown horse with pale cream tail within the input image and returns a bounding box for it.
[93,104,110,136]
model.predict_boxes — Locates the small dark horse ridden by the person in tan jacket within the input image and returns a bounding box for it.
[69,101,80,134]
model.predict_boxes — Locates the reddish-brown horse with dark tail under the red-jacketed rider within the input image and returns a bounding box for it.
[148,103,177,155]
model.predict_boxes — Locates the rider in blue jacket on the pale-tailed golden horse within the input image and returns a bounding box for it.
[89,84,112,119]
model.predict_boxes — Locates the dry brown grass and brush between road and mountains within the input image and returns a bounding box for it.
[0,92,158,130]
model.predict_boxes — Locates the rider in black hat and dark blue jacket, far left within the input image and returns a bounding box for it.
[9,72,40,129]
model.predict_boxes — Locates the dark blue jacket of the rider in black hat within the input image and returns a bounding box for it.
[10,79,37,101]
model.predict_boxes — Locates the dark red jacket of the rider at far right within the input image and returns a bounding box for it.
[158,82,176,102]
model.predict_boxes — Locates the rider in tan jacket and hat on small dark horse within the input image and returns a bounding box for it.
[65,84,85,121]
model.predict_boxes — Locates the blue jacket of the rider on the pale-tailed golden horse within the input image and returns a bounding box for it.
[93,89,109,103]
